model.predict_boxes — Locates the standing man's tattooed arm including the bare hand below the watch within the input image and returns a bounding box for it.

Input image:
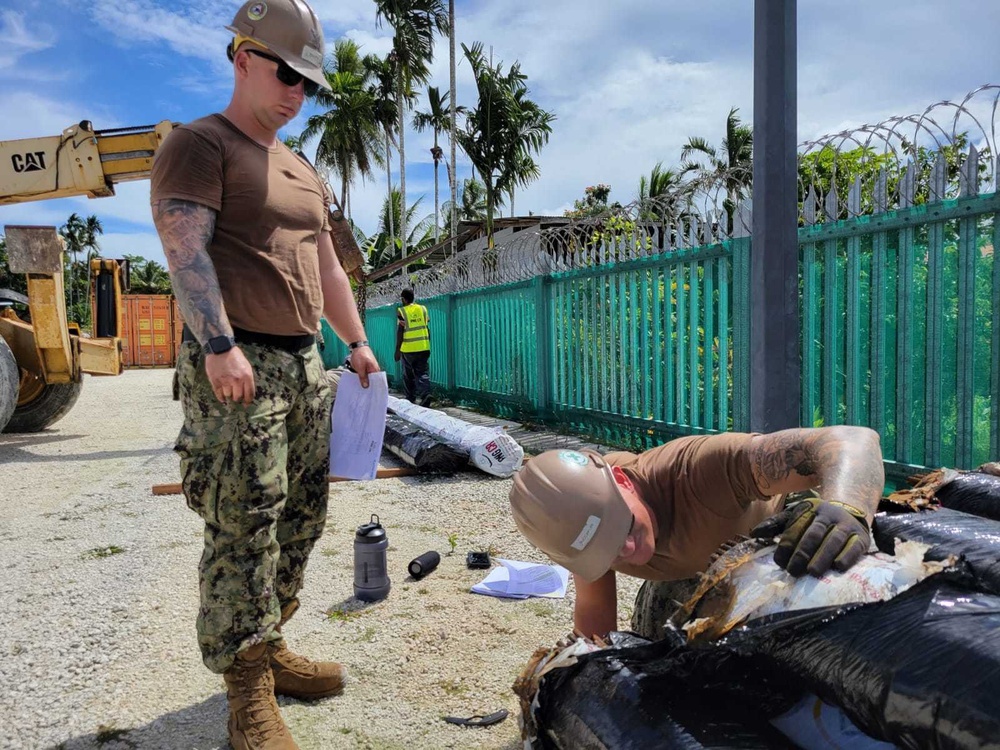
[153,199,255,404]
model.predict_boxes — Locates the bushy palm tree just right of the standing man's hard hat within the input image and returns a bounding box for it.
[299,39,382,213]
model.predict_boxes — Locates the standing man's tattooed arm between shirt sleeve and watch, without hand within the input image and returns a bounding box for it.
[153,199,233,344]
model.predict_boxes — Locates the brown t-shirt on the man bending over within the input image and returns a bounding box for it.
[605,432,782,581]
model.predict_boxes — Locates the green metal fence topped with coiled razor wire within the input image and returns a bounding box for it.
[356,194,1000,474]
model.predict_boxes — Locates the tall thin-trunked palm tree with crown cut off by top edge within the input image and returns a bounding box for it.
[375,0,448,266]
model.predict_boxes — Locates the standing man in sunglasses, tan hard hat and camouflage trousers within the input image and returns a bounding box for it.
[152,0,379,750]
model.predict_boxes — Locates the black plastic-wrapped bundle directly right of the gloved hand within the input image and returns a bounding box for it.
[874,508,1000,594]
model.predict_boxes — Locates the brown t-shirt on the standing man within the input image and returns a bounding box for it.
[150,115,330,336]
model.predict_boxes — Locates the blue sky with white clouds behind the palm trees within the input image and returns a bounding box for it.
[0,0,1000,270]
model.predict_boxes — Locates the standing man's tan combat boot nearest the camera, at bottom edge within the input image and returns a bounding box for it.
[223,643,299,750]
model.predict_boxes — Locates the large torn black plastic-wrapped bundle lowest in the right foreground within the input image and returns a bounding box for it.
[536,573,1000,750]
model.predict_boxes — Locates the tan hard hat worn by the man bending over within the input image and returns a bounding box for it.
[510,450,632,581]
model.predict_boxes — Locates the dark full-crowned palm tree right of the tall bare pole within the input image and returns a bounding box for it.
[455,42,555,247]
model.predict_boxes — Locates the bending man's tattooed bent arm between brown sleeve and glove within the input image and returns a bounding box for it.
[750,426,885,520]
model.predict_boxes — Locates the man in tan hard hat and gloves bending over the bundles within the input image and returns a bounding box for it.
[510,426,885,638]
